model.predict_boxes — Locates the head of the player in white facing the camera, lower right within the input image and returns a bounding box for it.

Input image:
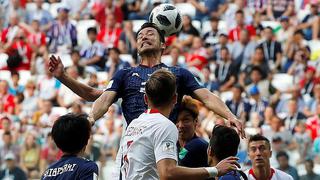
[248,134,272,168]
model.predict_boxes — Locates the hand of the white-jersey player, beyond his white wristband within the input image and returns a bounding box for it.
[215,157,241,176]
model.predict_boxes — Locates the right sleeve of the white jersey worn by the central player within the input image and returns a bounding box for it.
[153,120,178,162]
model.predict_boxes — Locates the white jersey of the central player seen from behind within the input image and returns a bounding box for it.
[121,110,178,180]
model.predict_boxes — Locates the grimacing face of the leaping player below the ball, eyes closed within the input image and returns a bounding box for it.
[137,27,163,55]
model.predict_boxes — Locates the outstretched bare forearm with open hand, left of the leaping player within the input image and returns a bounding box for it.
[49,55,103,101]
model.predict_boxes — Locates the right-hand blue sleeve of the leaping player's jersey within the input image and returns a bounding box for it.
[180,68,203,95]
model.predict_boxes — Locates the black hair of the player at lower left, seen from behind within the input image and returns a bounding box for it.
[51,113,91,154]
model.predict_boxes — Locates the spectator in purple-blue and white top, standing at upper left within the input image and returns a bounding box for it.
[47,7,78,54]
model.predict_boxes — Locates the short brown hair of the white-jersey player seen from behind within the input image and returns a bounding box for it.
[146,69,176,107]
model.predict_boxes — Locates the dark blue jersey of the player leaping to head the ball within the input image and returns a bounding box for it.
[106,63,202,124]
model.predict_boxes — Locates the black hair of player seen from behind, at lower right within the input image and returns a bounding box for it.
[209,125,240,161]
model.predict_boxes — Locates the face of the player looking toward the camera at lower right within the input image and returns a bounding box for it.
[248,140,272,168]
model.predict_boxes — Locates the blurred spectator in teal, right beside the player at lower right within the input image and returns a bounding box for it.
[277,151,299,180]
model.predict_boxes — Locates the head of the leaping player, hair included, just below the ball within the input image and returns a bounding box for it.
[137,22,165,56]
